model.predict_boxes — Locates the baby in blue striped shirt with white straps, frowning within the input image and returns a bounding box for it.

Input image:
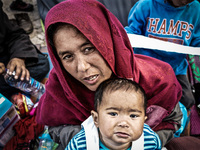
[66,78,161,150]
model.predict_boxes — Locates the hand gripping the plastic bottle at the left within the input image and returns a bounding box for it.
[7,58,30,80]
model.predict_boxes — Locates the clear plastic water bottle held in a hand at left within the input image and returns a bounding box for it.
[4,70,45,101]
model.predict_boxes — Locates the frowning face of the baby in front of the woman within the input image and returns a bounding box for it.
[94,91,146,149]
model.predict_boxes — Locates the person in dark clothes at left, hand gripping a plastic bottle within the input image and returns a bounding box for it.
[0,1,49,99]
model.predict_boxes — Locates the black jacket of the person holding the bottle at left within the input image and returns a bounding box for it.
[0,0,38,60]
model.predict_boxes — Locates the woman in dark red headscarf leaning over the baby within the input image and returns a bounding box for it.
[36,0,182,146]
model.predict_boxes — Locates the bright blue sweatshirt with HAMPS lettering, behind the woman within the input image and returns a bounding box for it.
[125,0,200,75]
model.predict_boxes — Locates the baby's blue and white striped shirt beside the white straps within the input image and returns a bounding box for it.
[65,124,161,150]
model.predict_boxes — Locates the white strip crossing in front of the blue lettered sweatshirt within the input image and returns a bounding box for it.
[128,34,200,55]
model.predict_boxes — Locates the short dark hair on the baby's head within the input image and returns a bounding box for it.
[94,78,147,114]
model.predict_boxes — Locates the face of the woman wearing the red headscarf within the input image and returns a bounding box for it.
[53,26,112,91]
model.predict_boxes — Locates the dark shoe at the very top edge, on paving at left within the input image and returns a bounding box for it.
[10,0,34,12]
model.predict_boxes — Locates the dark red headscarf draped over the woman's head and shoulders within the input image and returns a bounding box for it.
[37,0,181,129]
